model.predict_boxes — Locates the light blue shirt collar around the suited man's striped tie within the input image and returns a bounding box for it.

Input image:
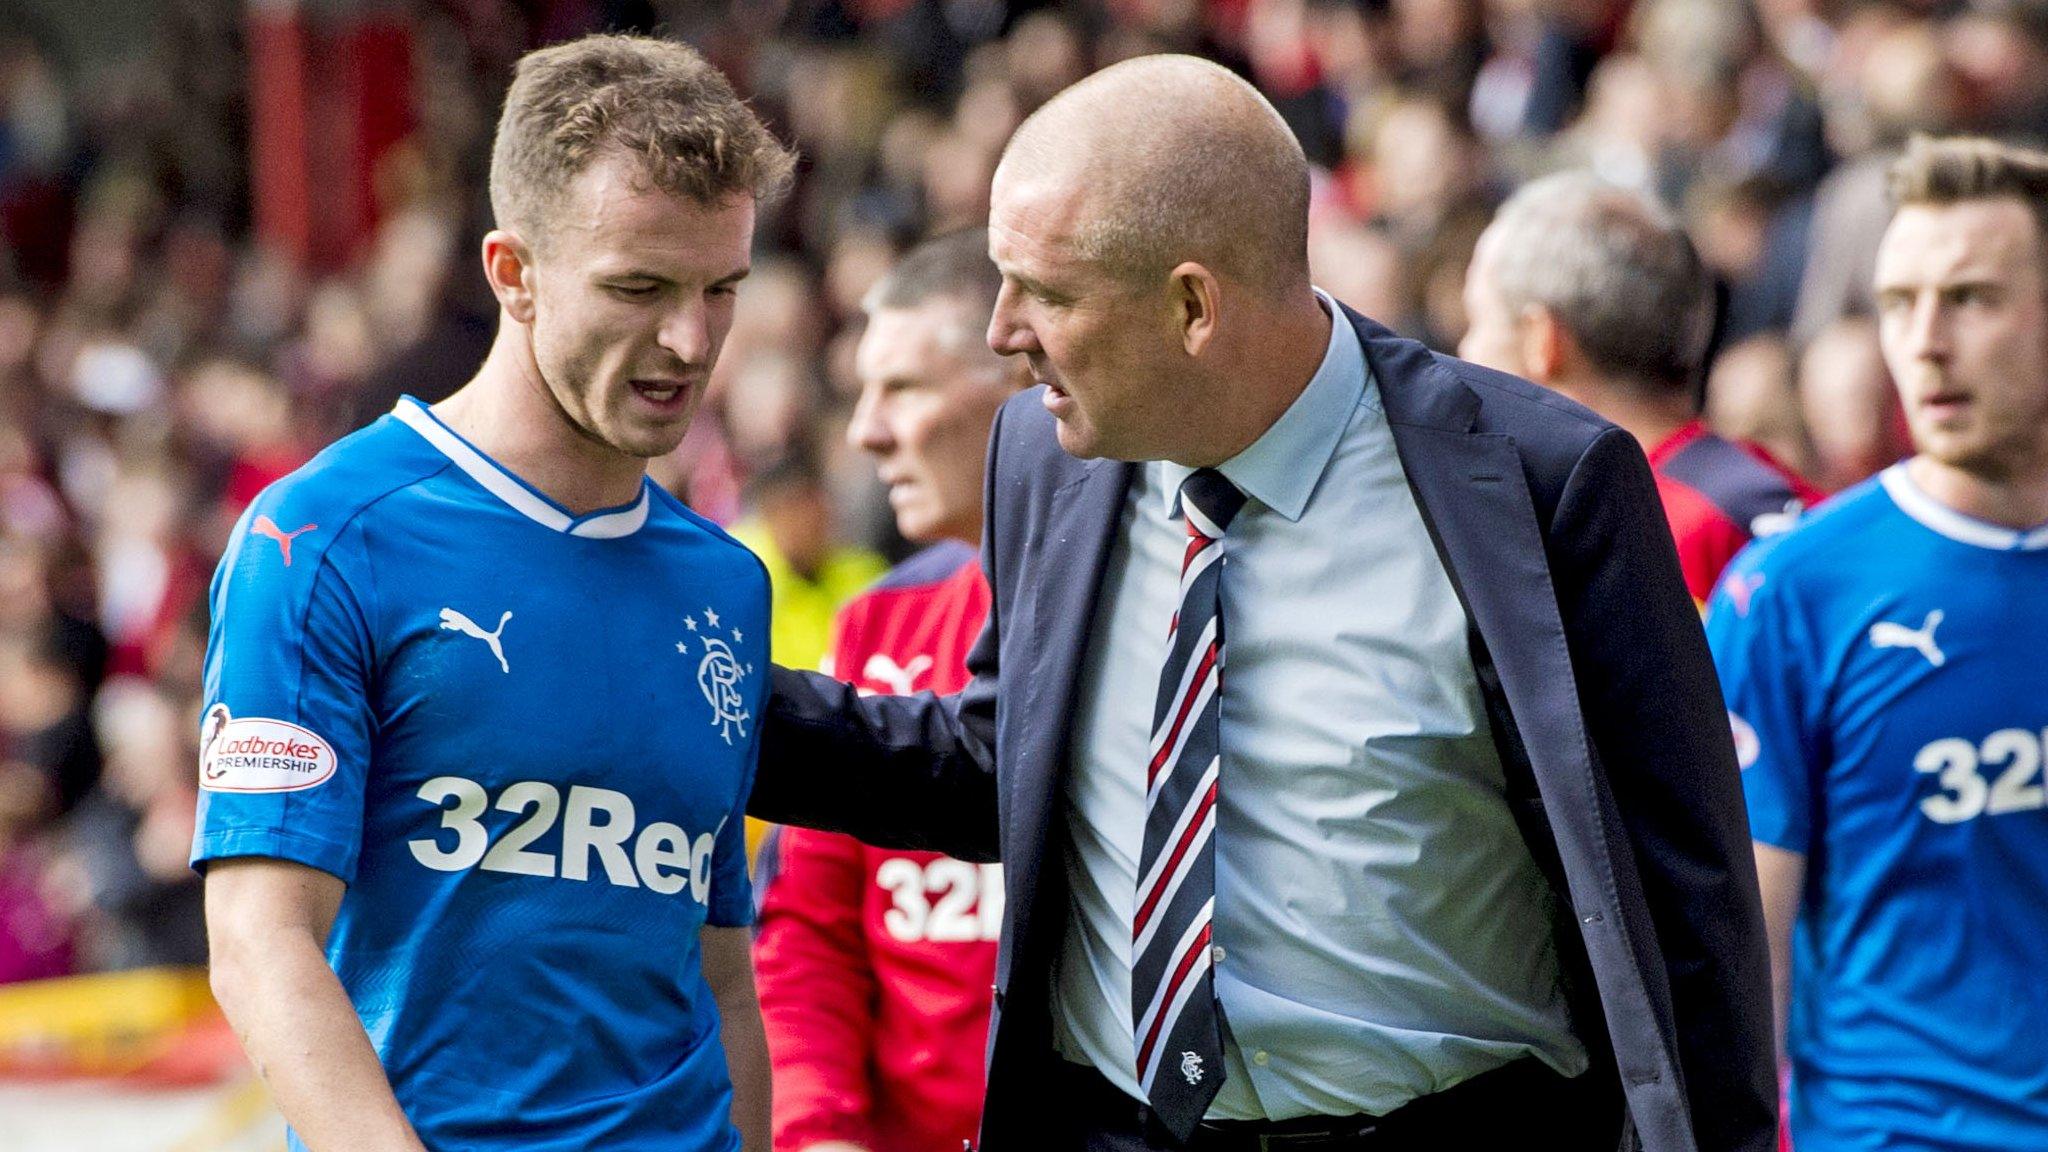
[1159,289,1372,521]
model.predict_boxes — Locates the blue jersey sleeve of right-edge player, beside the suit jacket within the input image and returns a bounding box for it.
[1706,543,1821,855]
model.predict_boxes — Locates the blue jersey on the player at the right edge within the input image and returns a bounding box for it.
[1706,465,2048,1152]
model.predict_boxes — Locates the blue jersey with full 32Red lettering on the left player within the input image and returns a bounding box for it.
[193,398,768,1152]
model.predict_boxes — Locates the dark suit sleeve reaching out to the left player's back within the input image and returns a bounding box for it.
[748,403,1004,861]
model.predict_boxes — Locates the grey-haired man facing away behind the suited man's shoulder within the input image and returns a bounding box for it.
[1458,172,1821,605]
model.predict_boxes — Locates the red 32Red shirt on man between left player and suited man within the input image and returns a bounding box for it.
[754,543,1004,1152]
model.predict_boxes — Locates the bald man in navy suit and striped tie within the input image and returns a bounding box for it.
[754,55,1776,1152]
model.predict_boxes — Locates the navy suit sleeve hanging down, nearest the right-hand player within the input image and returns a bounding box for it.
[1548,428,1778,1152]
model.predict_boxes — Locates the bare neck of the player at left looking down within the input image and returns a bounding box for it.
[434,315,647,508]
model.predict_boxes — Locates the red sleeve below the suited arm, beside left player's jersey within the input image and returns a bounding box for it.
[754,828,877,1152]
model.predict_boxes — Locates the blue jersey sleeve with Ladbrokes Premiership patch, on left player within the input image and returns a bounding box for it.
[193,500,373,881]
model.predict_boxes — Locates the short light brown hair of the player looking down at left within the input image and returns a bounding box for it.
[492,35,797,244]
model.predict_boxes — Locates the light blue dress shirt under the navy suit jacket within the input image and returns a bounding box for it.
[1053,293,1587,1119]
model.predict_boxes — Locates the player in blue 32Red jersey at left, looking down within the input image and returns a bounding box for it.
[193,37,793,1152]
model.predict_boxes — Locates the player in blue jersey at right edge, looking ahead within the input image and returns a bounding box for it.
[1708,139,2048,1152]
